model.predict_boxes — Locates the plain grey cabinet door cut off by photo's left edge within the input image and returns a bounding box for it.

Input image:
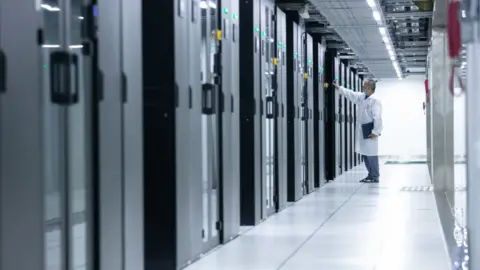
[0,0,44,270]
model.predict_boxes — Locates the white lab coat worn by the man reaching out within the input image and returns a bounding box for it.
[338,87,383,156]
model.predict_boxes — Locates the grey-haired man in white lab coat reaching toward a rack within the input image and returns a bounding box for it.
[333,79,383,183]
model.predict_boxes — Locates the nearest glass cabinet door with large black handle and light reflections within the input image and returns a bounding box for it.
[41,0,93,269]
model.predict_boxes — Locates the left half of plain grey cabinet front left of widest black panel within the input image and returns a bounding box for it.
[96,1,124,269]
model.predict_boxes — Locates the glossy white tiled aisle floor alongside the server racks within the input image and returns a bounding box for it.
[186,162,450,270]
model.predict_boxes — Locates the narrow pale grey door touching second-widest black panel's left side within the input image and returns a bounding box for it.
[222,0,244,243]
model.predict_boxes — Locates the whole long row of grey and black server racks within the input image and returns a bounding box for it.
[0,0,362,270]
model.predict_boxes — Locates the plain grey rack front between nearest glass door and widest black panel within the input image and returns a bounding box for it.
[97,1,144,269]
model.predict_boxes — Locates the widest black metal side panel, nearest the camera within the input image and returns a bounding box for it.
[142,0,179,270]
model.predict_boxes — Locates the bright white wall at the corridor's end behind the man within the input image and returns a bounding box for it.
[376,75,427,156]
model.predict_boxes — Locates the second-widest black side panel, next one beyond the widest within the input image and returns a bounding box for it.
[240,1,261,225]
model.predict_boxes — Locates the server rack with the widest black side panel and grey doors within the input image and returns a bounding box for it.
[141,0,239,269]
